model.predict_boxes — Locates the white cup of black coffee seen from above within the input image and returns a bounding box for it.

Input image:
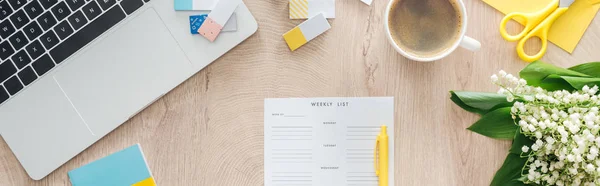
[384,0,481,62]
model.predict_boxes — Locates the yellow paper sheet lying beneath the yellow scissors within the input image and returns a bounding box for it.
[483,0,600,53]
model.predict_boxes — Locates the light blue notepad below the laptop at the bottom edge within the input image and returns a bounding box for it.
[69,144,156,186]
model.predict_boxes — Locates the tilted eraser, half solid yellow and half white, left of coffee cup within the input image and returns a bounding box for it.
[283,14,331,51]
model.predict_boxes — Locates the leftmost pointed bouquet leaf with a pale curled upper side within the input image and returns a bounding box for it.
[450,91,513,115]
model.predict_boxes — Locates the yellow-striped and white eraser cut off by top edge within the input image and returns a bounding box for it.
[289,0,335,19]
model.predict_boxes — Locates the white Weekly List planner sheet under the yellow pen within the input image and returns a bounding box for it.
[264,97,394,186]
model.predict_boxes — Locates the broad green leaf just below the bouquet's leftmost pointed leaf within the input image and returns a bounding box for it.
[467,107,519,139]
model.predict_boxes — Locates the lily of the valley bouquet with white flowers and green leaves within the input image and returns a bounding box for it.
[450,61,600,186]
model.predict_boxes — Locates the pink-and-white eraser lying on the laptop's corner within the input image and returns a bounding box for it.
[198,0,242,42]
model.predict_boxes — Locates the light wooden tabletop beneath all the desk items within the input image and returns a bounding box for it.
[0,0,600,186]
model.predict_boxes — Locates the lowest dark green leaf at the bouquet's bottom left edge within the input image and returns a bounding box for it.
[490,153,527,186]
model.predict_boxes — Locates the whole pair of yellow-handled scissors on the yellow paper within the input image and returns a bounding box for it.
[500,0,575,62]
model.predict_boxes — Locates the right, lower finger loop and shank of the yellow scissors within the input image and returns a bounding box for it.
[517,7,568,62]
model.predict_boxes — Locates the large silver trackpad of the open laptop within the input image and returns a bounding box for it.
[54,8,192,135]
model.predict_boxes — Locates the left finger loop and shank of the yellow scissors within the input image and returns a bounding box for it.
[500,0,559,41]
